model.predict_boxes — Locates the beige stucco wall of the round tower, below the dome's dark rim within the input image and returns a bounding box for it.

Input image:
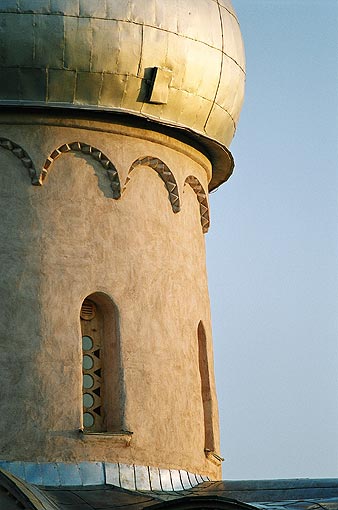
[0,114,220,478]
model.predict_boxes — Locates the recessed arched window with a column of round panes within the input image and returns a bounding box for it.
[80,292,123,433]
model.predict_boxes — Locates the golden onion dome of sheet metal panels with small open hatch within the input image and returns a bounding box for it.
[0,0,245,187]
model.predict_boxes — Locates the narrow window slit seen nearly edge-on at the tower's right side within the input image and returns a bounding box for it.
[197,321,215,453]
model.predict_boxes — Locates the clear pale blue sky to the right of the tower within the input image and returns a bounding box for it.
[207,0,338,479]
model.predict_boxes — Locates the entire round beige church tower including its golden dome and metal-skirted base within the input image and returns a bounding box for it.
[0,0,245,489]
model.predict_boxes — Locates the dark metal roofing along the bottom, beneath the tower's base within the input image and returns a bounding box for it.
[0,470,338,510]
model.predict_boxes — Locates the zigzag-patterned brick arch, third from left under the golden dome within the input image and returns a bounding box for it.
[122,156,181,213]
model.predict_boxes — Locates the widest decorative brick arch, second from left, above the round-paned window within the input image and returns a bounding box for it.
[40,142,121,199]
